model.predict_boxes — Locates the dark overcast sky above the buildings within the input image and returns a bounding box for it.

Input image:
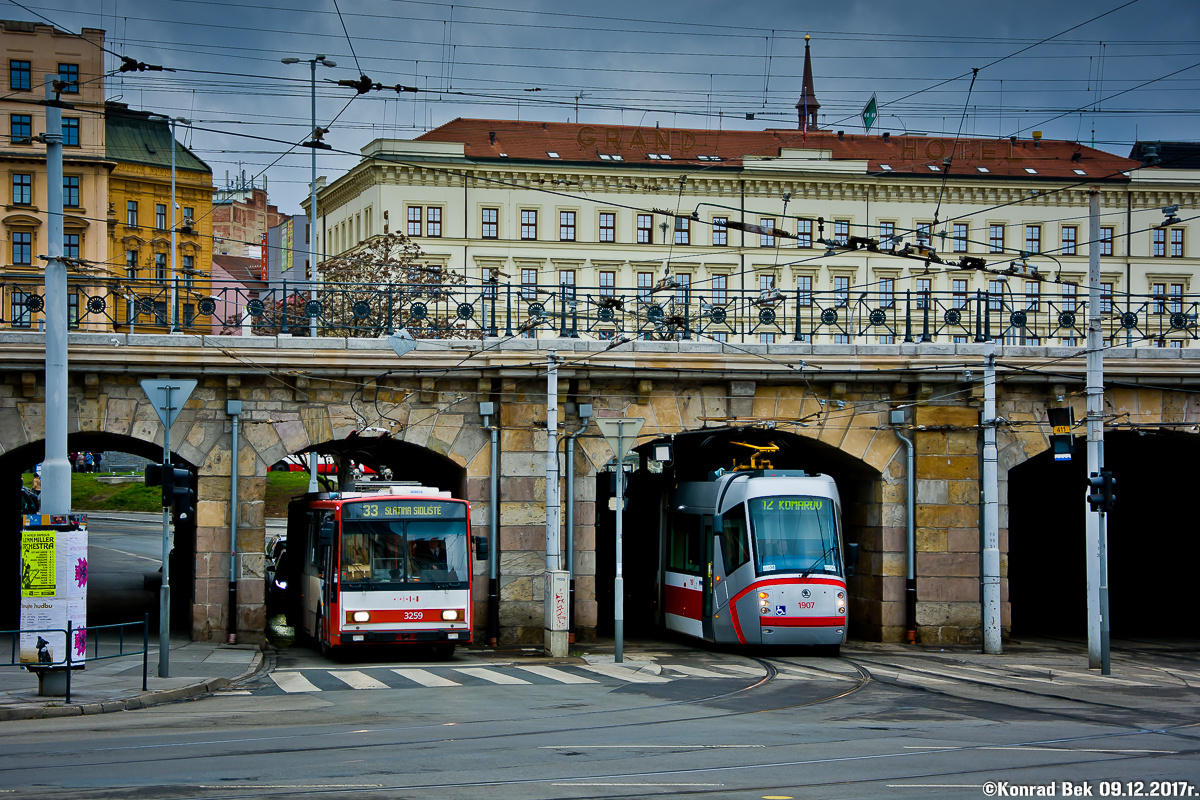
[18,0,1200,212]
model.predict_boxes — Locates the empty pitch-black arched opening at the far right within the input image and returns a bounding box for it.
[1008,431,1200,640]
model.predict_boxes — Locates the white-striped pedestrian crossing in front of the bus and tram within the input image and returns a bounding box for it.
[256,661,782,694]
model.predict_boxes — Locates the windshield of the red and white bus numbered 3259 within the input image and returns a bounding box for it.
[342,519,470,589]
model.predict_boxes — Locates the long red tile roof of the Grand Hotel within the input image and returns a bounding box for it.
[418,118,1140,181]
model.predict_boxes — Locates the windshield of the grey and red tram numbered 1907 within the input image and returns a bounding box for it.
[746,495,841,575]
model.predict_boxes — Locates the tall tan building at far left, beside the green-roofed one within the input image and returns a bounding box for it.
[0,20,110,329]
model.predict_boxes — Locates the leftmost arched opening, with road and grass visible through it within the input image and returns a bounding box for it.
[0,432,196,631]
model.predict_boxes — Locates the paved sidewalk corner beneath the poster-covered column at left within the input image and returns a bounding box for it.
[0,634,263,721]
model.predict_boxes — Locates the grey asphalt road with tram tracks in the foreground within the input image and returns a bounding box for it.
[0,645,1200,800]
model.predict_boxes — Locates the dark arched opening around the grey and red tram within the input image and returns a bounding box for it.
[595,427,882,637]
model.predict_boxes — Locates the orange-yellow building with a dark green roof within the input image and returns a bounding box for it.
[104,103,212,333]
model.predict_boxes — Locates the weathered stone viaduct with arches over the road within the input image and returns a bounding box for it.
[0,332,1200,644]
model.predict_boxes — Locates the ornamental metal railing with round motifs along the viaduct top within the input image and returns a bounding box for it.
[0,275,1200,347]
